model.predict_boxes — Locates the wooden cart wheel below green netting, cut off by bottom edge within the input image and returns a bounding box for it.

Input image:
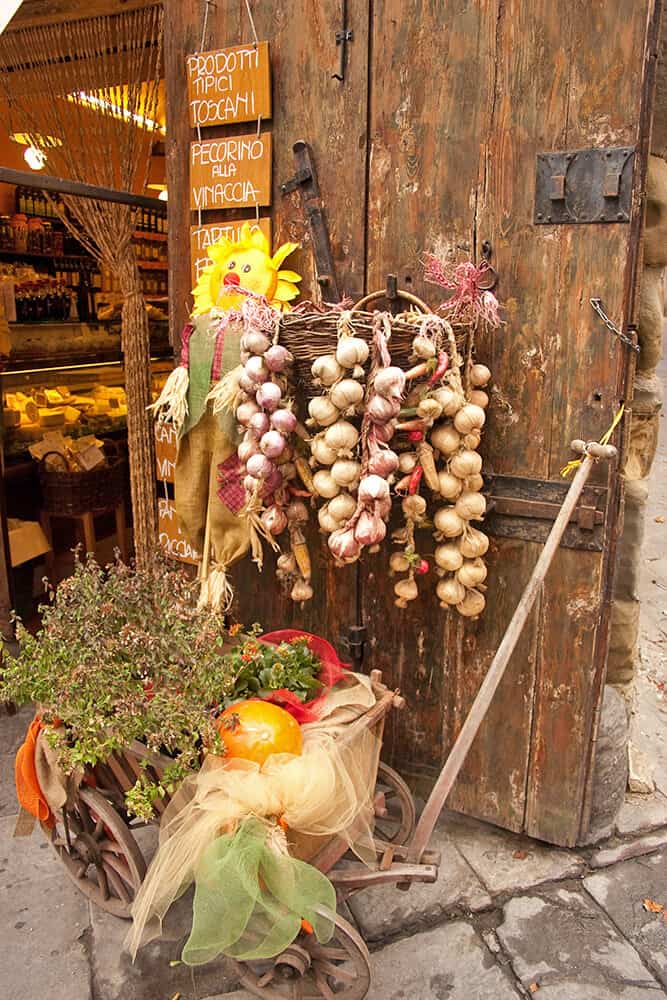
[233,914,371,1000]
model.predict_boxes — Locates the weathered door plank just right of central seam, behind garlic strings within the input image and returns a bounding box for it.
[360,0,495,796]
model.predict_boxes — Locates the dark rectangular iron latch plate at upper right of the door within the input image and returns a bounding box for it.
[534,146,635,226]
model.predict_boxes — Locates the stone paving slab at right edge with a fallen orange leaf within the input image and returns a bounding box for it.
[584,850,667,986]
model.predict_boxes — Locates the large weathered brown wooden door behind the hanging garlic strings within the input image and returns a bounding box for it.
[165,0,659,844]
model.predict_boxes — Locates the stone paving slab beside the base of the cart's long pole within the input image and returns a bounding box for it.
[349,830,491,941]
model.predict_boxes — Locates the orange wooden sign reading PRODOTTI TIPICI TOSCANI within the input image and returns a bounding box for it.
[187,42,271,128]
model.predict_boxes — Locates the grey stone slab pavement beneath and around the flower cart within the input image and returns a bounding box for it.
[0,688,667,1000]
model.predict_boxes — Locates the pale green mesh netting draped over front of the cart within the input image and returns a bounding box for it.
[182,818,336,965]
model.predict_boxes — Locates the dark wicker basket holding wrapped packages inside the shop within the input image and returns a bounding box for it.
[39,441,125,514]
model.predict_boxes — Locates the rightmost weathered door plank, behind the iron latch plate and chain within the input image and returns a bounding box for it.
[526,0,652,844]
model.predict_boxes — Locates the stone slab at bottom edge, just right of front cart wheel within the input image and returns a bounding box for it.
[207,920,520,1000]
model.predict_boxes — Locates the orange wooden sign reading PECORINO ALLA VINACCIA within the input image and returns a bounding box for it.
[190,132,271,210]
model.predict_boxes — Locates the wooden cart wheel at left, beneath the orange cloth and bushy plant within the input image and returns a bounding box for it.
[43,786,146,918]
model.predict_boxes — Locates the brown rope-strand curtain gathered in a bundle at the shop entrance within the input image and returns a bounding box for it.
[0,4,162,566]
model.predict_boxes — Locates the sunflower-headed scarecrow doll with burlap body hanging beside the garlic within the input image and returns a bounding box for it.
[152,223,301,607]
